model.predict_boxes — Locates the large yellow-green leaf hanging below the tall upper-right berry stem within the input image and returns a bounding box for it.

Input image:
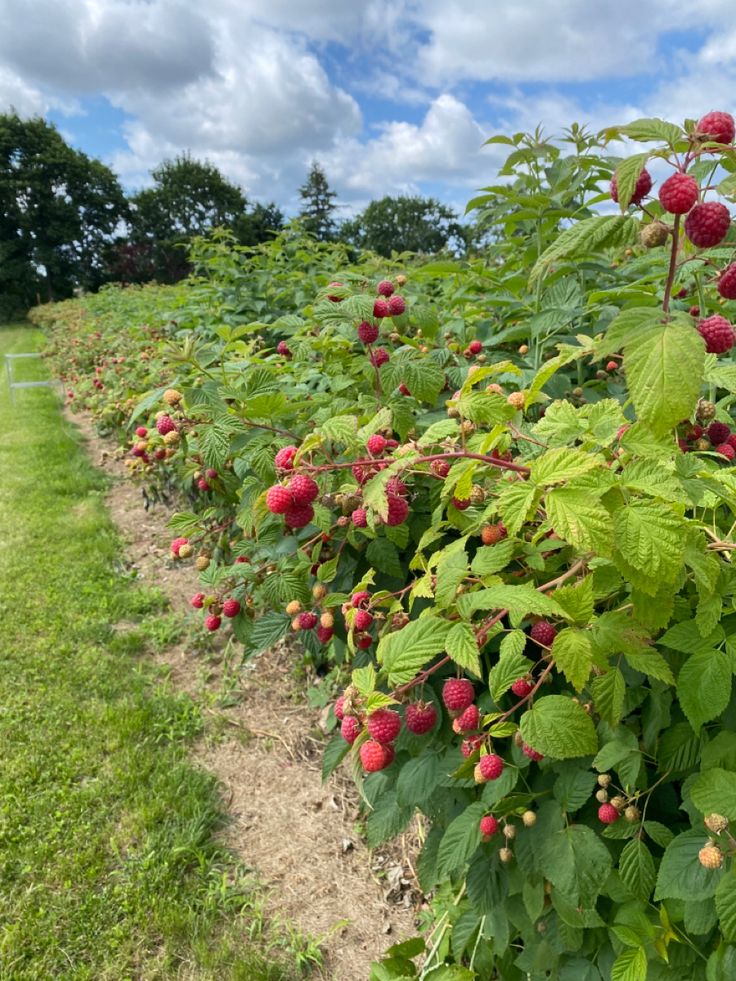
[624,320,705,435]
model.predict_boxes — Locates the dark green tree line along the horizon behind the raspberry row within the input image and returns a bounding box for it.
[0,112,475,318]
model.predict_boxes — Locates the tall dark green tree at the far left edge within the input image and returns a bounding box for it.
[0,113,127,313]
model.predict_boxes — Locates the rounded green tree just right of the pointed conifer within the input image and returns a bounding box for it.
[341,195,468,258]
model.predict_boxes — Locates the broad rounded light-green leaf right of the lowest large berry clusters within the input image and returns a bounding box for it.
[520,695,598,760]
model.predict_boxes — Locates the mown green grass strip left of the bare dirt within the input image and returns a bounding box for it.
[0,325,319,981]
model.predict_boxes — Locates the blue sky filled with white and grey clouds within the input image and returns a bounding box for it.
[0,0,736,216]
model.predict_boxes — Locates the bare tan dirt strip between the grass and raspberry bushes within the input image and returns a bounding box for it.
[67,415,420,981]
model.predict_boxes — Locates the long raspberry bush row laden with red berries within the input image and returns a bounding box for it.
[34,113,736,981]
